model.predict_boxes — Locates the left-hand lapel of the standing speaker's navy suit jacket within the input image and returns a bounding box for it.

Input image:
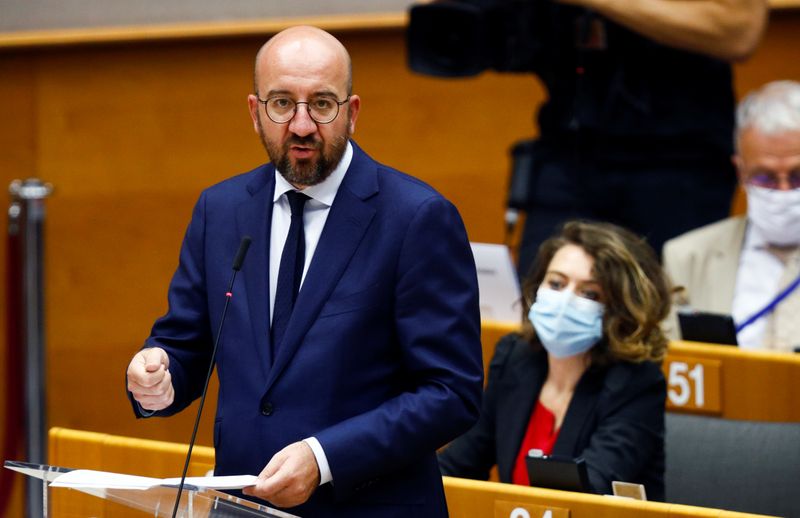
[236,164,275,375]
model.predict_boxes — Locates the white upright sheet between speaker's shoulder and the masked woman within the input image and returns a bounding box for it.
[470,243,521,325]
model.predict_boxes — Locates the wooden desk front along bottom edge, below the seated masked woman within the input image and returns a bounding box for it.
[444,477,763,518]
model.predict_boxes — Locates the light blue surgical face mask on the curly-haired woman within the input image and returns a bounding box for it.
[528,287,605,358]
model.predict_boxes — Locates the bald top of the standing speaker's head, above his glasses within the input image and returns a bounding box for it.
[253,25,353,95]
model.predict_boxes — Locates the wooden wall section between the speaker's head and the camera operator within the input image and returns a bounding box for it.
[334,26,544,242]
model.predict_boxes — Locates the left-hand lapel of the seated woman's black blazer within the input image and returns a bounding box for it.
[497,350,547,481]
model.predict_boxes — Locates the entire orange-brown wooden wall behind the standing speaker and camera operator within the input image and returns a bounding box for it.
[0,11,800,510]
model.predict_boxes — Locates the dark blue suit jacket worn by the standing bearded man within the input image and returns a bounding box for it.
[137,144,483,516]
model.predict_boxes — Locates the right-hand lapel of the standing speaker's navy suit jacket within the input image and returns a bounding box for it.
[260,143,378,390]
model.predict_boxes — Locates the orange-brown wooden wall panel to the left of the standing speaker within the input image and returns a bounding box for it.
[39,41,262,444]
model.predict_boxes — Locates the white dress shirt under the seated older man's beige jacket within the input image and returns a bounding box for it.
[731,225,786,349]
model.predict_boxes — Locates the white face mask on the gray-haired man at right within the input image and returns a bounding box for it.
[745,185,800,246]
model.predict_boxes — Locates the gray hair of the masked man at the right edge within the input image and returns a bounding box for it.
[734,81,800,149]
